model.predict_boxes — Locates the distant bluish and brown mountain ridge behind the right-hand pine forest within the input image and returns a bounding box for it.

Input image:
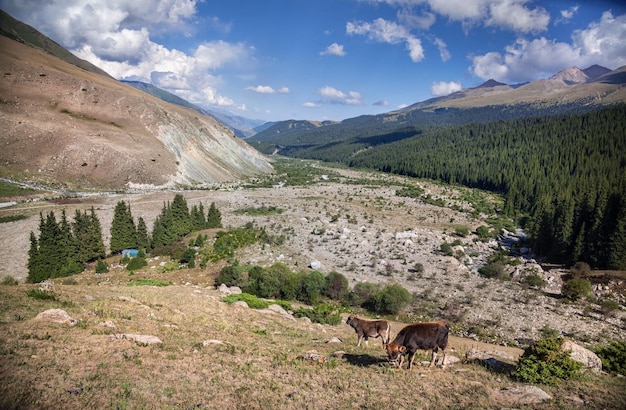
[248,65,626,154]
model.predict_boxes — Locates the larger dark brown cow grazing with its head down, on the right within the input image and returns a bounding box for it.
[385,321,450,369]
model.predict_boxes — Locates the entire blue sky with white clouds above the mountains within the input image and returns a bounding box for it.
[0,0,626,121]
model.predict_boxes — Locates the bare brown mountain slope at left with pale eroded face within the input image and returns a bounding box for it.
[0,11,272,189]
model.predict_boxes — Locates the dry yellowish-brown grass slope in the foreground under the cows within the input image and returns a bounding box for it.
[0,271,626,409]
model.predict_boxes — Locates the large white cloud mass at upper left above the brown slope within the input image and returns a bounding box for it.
[6,0,252,106]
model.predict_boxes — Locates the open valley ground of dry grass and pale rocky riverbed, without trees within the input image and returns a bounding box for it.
[0,162,626,409]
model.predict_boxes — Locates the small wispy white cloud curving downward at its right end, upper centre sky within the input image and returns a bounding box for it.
[346,18,424,62]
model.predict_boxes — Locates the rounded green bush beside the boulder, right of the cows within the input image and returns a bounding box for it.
[512,337,582,385]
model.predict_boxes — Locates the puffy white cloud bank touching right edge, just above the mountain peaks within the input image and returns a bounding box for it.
[470,12,626,83]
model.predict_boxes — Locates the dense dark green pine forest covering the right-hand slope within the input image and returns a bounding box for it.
[281,105,626,269]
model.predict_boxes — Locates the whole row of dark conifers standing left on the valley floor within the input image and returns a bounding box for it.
[27,194,222,283]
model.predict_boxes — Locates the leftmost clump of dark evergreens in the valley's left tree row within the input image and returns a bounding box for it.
[27,208,106,283]
